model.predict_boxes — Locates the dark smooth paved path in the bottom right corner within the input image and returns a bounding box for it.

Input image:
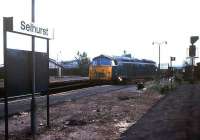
[121,84,200,140]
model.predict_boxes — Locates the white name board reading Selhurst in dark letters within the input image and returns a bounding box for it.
[13,18,53,39]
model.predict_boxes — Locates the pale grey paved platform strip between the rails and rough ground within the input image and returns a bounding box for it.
[0,85,136,119]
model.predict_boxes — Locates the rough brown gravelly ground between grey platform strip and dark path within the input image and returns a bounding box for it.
[0,83,162,140]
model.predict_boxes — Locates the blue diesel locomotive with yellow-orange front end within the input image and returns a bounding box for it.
[89,55,156,82]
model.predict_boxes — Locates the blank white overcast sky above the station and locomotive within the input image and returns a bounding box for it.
[0,0,200,65]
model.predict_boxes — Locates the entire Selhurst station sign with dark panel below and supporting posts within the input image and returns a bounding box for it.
[3,17,53,140]
